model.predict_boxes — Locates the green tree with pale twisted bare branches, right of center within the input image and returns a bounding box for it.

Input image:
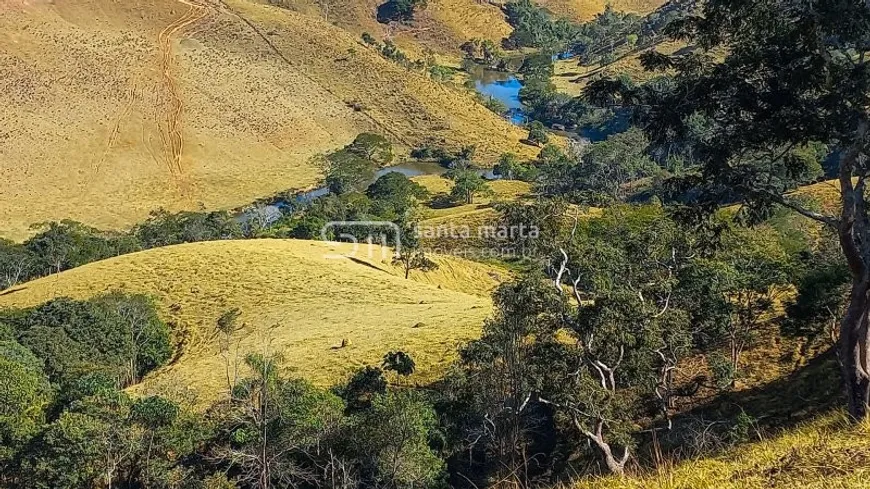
[553,206,697,473]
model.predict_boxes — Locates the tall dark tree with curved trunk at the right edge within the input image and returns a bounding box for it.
[587,0,870,419]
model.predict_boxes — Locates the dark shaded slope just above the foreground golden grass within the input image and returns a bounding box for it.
[652,349,845,466]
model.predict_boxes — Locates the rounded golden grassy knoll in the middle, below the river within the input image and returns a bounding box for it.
[0,240,508,403]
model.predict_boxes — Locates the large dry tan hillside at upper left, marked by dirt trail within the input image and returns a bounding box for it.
[0,0,529,239]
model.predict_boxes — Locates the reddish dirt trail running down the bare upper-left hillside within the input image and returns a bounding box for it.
[157,0,208,180]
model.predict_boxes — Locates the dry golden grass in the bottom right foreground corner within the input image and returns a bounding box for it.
[572,413,870,489]
